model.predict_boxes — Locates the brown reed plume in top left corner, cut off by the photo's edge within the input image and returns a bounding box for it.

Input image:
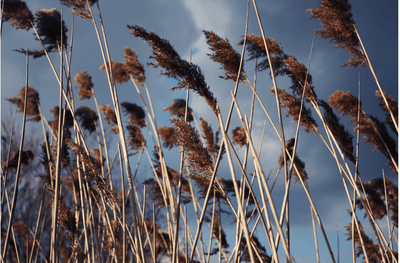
[1,0,34,31]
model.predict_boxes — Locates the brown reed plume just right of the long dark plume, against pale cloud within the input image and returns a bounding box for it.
[203,30,245,82]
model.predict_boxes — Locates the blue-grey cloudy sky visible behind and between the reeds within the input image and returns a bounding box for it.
[1,0,398,262]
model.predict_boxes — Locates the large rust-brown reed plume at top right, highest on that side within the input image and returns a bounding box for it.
[307,0,367,67]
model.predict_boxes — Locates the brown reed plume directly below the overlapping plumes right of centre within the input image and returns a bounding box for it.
[269,88,319,134]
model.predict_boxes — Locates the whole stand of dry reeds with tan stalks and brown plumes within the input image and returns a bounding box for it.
[1,0,398,263]
